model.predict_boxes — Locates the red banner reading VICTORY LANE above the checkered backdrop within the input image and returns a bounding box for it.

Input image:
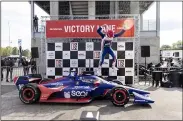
[46,19,134,38]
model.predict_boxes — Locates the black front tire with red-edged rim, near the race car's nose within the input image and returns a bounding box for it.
[111,87,130,106]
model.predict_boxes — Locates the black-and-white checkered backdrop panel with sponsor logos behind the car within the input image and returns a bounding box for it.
[47,42,134,84]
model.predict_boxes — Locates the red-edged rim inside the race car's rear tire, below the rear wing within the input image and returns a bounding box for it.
[23,88,35,101]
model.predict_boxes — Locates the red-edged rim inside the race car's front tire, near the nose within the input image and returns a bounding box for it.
[113,90,126,103]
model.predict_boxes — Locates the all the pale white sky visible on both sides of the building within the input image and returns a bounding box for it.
[1,2,182,49]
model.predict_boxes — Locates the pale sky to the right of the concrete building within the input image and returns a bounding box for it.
[143,2,182,46]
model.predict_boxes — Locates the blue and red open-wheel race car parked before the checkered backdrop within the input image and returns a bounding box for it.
[14,69,154,106]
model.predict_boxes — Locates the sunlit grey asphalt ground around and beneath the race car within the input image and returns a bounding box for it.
[1,83,182,120]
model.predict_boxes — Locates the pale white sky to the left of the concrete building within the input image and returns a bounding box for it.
[1,2,48,49]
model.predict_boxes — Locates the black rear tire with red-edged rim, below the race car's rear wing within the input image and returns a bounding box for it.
[19,84,40,104]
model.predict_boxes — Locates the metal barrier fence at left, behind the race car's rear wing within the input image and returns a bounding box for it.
[1,66,39,82]
